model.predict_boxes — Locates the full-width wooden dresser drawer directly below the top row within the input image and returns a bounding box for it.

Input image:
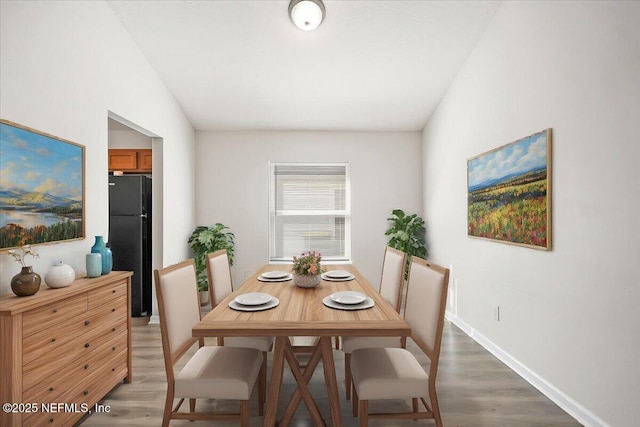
[22,298,128,371]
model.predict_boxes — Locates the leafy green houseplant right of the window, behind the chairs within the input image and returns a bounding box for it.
[384,209,427,279]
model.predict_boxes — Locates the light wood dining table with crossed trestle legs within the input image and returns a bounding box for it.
[192,264,411,426]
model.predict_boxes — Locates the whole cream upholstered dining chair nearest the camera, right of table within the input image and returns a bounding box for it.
[351,257,449,427]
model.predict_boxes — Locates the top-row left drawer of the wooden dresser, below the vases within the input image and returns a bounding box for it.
[22,293,87,338]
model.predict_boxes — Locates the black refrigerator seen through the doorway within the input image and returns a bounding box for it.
[109,175,152,317]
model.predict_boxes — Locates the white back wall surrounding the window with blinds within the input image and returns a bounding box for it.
[196,132,422,287]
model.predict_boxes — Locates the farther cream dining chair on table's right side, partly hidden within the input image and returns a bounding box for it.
[341,246,407,400]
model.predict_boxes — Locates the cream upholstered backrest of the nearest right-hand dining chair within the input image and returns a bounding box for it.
[404,256,449,367]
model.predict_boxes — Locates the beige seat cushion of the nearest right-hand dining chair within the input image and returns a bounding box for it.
[351,348,429,400]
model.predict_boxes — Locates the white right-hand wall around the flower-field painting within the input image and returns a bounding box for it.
[423,1,640,427]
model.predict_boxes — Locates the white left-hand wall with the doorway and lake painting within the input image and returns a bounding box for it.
[0,1,195,294]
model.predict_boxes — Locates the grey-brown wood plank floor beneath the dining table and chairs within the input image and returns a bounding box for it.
[81,322,581,427]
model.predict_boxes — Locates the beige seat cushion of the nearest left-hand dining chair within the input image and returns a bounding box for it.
[175,346,262,400]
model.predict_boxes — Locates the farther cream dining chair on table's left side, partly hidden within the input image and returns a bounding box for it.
[207,249,273,395]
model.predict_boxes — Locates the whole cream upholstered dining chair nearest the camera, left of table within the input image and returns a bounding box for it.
[154,259,264,427]
